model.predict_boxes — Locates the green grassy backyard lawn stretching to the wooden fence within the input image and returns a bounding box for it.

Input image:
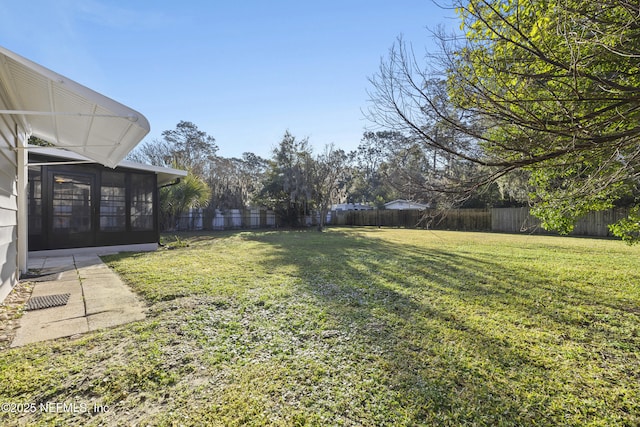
[0,228,640,426]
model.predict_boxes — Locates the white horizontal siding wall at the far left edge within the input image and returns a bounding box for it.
[0,106,18,302]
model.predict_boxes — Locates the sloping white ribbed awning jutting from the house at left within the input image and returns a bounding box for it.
[0,46,150,167]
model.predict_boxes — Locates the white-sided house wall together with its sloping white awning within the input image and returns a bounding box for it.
[0,47,150,301]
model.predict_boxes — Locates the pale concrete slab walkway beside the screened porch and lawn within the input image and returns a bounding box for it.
[11,253,146,347]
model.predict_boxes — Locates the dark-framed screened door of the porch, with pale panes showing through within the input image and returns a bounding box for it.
[50,172,95,248]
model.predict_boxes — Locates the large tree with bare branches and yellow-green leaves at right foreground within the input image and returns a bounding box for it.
[370,0,640,240]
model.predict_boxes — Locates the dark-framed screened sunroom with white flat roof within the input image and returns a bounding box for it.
[28,146,186,251]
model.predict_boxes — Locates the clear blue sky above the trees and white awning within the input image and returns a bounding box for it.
[0,0,457,157]
